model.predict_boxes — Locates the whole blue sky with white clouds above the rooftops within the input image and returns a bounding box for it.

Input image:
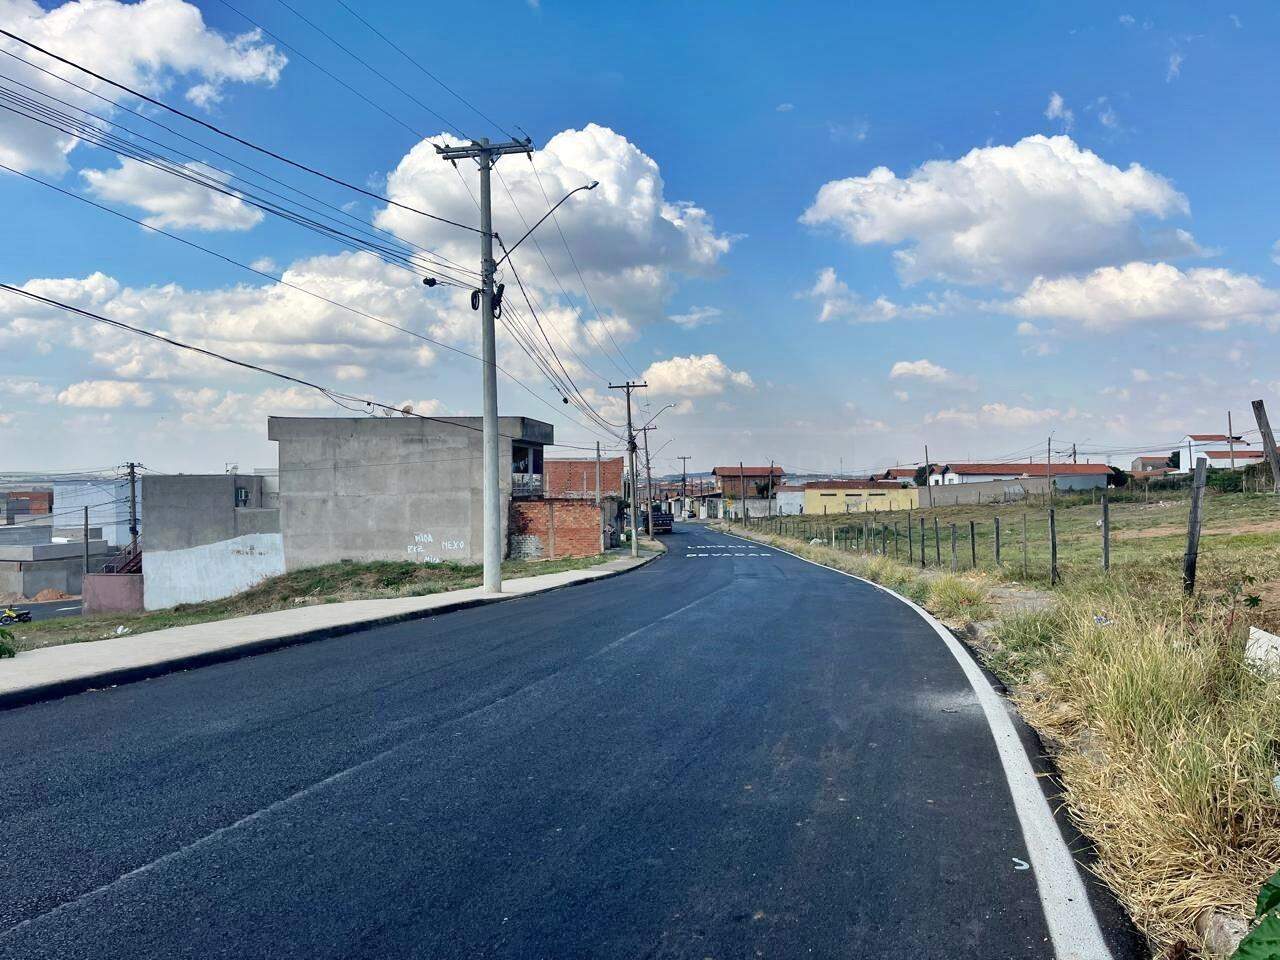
[0,0,1280,470]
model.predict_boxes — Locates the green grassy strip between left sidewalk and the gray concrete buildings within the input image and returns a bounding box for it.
[0,554,621,669]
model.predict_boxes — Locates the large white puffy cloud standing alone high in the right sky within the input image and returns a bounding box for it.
[801,136,1198,287]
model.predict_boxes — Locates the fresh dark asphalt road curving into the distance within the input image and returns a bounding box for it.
[0,524,1140,960]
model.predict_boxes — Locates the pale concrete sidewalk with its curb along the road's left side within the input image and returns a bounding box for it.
[0,552,662,710]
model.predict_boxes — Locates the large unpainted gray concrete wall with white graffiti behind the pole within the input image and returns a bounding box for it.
[268,417,554,570]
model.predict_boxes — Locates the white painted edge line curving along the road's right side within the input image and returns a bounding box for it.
[728,534,1112,960]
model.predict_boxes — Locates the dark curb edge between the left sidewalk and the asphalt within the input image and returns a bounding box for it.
[0,550,666,710]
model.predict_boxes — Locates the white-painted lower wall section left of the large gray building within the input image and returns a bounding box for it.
[142,534,284,611]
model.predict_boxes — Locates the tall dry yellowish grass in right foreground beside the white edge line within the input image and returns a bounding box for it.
[992,594,1280,947]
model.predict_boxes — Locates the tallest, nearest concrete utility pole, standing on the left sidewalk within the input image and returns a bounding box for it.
[435,137,532,594]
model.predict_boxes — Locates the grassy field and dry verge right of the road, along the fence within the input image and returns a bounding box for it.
[716,494,1280,951]
